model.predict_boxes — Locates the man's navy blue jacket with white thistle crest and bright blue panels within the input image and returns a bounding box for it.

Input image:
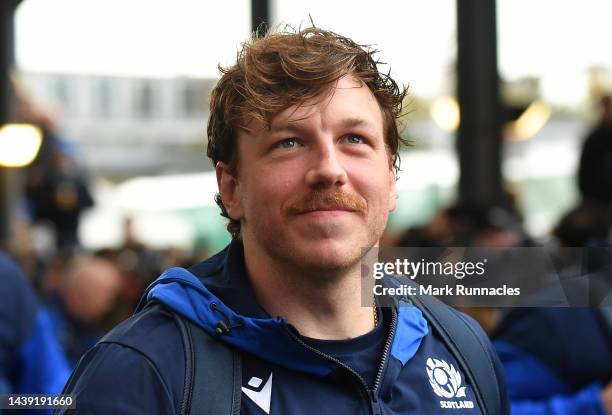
[58,242,500,415]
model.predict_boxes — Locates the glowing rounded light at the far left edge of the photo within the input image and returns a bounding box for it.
[0,124,42,167]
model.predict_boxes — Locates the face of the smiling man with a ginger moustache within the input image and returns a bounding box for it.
[217,75,395,272]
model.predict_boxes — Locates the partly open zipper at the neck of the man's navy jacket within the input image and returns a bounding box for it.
[287,308,397,415]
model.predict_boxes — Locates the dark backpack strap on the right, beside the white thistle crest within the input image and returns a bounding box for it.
[410,295,509,415]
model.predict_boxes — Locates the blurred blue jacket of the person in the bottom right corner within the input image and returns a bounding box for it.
[493,308,612,415]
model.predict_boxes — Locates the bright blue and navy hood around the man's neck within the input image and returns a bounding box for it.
[136,241,428,376]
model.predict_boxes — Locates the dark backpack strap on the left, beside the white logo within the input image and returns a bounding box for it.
[176,315,242,415]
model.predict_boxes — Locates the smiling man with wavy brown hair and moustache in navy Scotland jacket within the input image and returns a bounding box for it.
[57,27,507,414]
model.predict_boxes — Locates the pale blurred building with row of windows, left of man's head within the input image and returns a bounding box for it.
[22,72,215,178]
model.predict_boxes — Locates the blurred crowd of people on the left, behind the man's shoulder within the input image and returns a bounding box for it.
[0,80,205,413]
